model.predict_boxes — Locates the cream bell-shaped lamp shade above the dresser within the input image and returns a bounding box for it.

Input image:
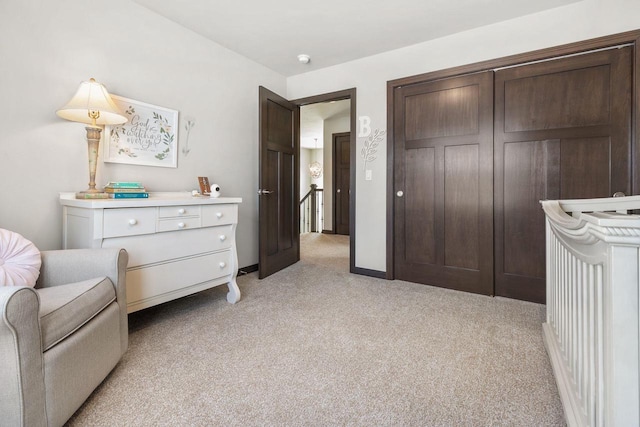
[56,79,127,126]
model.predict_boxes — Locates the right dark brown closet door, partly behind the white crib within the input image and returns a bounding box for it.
[495,47,631,303]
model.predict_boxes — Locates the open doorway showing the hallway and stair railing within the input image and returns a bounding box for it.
[293,89,355,271]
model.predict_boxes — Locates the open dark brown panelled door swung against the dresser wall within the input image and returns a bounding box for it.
[258,87,300,279]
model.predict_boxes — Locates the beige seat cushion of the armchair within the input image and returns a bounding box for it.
[36,277,116,351]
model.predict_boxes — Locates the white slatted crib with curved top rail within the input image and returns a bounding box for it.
[541,196,640,426]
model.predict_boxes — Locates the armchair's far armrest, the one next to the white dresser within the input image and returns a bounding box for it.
[36,248,129,353]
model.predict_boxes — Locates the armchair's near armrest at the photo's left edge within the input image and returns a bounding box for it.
[0,286,46,426]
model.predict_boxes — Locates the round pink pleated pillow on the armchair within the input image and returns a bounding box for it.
[0,228,42,287]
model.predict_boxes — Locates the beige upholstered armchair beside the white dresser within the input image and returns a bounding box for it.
[0,249,128,427]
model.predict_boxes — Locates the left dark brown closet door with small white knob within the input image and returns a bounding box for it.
[393,72,493,295]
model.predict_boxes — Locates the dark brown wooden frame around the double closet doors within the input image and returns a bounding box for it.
[385,30,640,280]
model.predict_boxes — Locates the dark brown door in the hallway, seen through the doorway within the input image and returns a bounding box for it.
[333,132,351,235]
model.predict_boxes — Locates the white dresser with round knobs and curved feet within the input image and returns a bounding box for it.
[60,193,242,313]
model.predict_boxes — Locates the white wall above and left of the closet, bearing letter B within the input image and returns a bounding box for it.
[287,0,640,271]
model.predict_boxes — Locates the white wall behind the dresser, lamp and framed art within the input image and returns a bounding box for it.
[0,0,286,267]
